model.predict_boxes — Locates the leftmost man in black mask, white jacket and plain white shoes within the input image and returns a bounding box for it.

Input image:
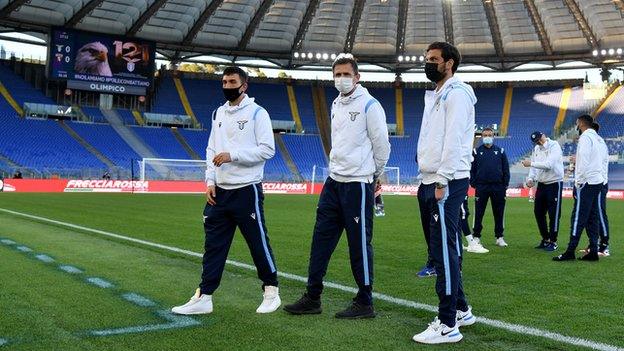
[171,67,281,314]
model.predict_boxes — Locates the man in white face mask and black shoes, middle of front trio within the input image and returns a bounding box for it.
[284,54,390,318]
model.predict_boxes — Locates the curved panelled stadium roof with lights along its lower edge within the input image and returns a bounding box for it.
[0,0,624,72]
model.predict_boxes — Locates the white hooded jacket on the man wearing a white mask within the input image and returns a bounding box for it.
[329,85,390,183]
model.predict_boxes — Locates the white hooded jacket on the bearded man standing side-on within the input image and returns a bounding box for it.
[417,77,477,184]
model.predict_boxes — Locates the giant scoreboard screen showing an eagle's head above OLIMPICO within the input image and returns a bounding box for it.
[48,28,155,95]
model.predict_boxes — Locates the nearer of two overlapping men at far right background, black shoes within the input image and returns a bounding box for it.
[553,115,607,261]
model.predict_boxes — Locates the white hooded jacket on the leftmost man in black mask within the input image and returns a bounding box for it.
[206,95,275,190]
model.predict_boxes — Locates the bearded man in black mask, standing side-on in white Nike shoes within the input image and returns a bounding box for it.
[413,42,477,344]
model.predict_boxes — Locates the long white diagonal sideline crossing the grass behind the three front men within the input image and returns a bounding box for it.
[0,208,624,351]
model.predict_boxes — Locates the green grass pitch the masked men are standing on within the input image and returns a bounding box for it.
[0,193,624,350]
